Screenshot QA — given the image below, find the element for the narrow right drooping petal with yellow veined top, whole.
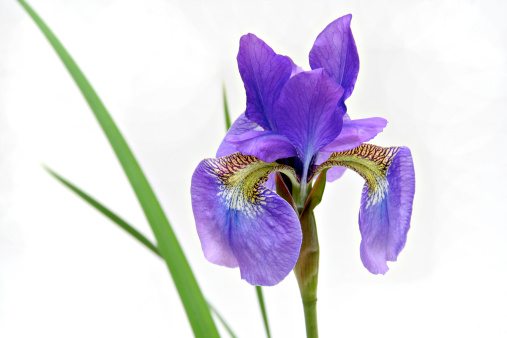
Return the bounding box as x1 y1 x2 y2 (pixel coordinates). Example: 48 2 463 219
316 144 415 274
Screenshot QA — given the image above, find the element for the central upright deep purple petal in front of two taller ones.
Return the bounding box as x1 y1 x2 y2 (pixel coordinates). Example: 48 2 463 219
274 69 343 163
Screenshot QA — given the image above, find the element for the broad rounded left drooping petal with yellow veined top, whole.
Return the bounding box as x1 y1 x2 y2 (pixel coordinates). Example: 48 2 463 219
191 153 302 285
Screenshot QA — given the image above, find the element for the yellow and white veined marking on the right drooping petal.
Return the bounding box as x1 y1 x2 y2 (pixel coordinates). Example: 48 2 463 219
312 143 400 208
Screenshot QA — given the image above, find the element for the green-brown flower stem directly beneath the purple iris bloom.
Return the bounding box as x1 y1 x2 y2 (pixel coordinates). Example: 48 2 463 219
294 210 319 338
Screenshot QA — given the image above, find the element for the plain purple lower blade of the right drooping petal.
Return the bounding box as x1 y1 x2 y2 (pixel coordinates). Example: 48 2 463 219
359 147 415 274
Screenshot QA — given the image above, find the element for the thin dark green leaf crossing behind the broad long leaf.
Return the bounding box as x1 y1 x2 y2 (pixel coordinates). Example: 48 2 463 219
42 165 236 338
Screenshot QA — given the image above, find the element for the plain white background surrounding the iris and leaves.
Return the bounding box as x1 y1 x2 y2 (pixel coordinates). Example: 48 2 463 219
0 0 507 338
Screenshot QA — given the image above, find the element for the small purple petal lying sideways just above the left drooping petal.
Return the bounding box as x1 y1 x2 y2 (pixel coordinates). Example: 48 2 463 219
226 130 297 163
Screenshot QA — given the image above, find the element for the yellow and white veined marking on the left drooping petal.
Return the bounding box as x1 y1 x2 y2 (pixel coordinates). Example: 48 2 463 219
202 153 295 216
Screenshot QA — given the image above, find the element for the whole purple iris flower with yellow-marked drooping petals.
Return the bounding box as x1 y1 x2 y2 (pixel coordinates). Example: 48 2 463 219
191 14 415 285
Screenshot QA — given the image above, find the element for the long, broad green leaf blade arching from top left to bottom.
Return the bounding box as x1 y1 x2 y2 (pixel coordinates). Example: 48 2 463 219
18 0 219 338
